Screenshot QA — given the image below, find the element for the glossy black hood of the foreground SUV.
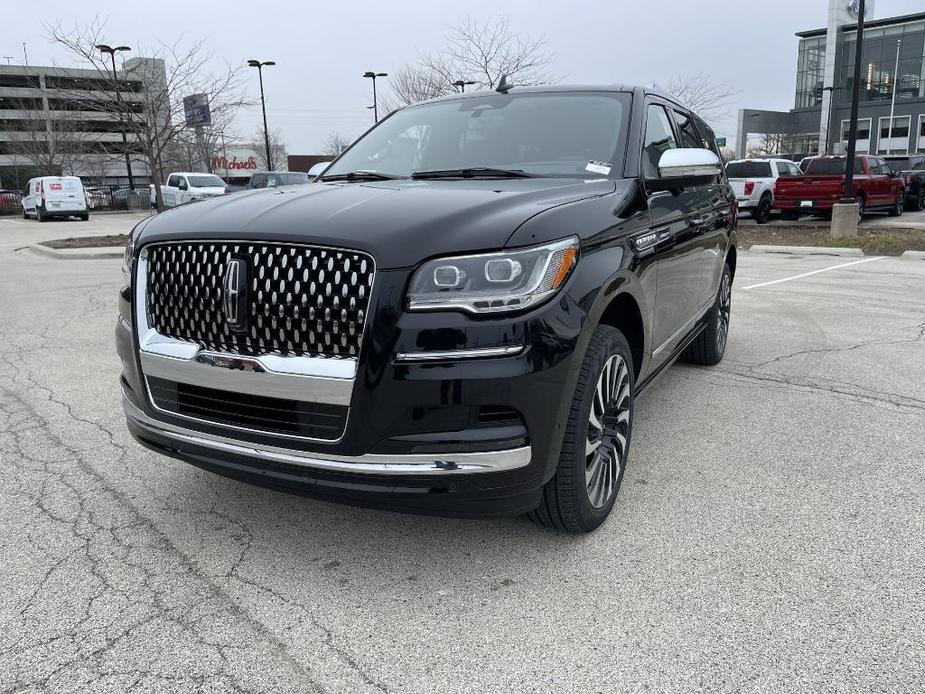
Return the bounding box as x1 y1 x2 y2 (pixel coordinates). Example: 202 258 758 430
139 178 616 269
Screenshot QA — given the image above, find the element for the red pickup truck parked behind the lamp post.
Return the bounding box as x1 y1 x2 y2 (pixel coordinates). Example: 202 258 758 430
774 154 906 219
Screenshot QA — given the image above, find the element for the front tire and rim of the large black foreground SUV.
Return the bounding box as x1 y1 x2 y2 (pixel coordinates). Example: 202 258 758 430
527 325 636 533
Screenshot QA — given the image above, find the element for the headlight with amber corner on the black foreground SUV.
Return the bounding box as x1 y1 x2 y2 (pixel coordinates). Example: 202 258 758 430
408 237 578 313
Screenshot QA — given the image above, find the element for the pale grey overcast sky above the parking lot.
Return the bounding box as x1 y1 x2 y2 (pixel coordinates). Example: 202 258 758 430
0 0 925 154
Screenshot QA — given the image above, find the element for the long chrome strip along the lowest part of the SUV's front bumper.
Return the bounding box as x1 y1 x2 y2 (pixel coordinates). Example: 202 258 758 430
122 392 532 475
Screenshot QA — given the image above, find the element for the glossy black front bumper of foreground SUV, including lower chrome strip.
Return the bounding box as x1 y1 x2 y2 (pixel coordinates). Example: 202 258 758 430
116 258 586 516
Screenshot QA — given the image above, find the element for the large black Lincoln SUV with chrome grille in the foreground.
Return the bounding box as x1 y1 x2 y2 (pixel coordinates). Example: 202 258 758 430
116 86 737 532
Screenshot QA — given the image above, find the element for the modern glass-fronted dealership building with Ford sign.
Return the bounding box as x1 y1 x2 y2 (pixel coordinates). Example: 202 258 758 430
737 13 925 156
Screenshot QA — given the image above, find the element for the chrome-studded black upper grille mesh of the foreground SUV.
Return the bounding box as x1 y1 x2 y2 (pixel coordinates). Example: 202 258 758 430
146 242 375 357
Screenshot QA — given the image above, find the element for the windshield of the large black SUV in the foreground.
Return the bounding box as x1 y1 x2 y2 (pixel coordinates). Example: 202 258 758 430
324 92 629 178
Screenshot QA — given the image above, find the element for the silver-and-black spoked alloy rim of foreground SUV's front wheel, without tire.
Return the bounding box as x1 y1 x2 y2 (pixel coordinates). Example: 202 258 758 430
585 354 632 508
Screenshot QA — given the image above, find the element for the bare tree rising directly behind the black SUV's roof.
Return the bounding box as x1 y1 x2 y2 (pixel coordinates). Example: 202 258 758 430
382 17 556 111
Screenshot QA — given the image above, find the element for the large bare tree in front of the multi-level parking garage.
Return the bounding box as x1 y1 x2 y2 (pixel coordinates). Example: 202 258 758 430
45 18 248 209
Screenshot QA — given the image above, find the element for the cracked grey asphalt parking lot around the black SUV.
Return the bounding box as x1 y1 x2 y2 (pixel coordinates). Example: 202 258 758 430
0 215 925 693
